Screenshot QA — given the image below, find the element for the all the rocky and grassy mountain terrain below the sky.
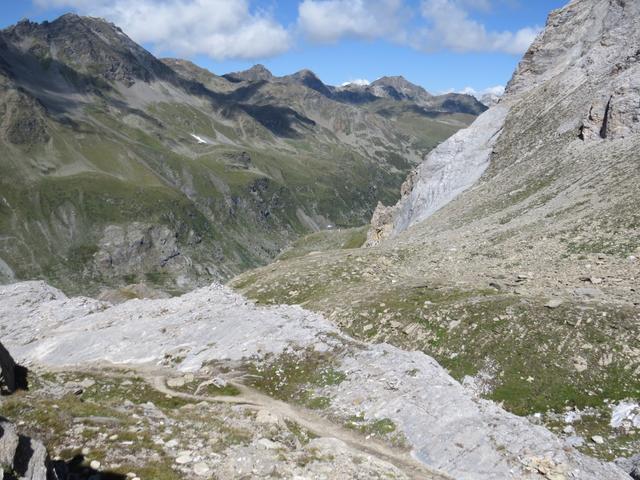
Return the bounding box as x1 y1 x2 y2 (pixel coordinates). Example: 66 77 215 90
0 0 640 480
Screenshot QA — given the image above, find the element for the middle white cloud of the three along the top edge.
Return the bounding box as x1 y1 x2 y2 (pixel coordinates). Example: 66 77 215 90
298 0 405 43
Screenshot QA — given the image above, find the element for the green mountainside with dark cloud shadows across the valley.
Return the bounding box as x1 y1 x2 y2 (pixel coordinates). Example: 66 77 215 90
0 15 474 293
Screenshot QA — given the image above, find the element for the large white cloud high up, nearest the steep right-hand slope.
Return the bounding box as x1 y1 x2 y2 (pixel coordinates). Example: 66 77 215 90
413 0 540 54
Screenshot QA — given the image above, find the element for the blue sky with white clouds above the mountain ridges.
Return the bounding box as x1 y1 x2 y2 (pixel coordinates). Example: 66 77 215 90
0 0 567 92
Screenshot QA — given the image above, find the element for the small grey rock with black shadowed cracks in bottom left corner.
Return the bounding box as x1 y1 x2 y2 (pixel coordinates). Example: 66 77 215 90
0 421 48 480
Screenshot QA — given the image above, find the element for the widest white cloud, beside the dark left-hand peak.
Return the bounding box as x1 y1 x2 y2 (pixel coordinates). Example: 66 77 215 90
35 0 292 60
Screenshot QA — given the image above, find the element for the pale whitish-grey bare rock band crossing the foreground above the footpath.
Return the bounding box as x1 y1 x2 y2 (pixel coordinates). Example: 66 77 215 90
0 282 628 480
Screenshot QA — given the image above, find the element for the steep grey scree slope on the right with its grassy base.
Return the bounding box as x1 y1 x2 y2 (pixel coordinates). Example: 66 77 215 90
231 0 640 458
